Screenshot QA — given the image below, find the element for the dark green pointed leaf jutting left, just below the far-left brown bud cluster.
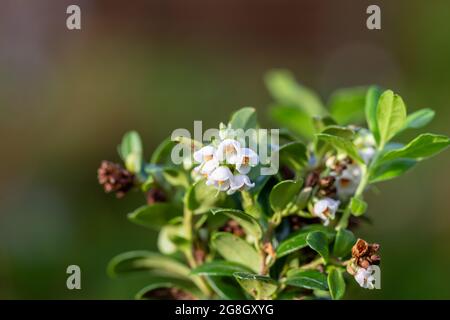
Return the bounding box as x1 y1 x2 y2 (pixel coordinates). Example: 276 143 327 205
128 202 183 230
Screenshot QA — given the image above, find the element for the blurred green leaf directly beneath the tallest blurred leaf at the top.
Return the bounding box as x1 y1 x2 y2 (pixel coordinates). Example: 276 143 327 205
269 105 315 139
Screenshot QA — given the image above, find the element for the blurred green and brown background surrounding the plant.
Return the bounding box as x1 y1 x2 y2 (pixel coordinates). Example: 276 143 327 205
0 0 450 299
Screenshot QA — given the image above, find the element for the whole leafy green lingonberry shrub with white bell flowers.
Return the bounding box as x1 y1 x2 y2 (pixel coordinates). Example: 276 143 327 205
98 71 449 299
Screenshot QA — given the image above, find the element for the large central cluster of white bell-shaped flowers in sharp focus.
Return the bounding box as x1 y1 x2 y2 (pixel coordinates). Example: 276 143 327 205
194 126 259 194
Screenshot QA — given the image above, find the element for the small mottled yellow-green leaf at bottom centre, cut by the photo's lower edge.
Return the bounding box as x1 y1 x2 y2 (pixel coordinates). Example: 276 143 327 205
234 272 278 299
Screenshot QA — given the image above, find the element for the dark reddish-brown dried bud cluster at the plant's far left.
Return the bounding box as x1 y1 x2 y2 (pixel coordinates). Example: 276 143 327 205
97 160 135 198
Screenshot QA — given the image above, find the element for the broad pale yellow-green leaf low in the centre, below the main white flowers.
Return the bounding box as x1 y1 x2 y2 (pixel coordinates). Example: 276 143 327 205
211 232 261 272
